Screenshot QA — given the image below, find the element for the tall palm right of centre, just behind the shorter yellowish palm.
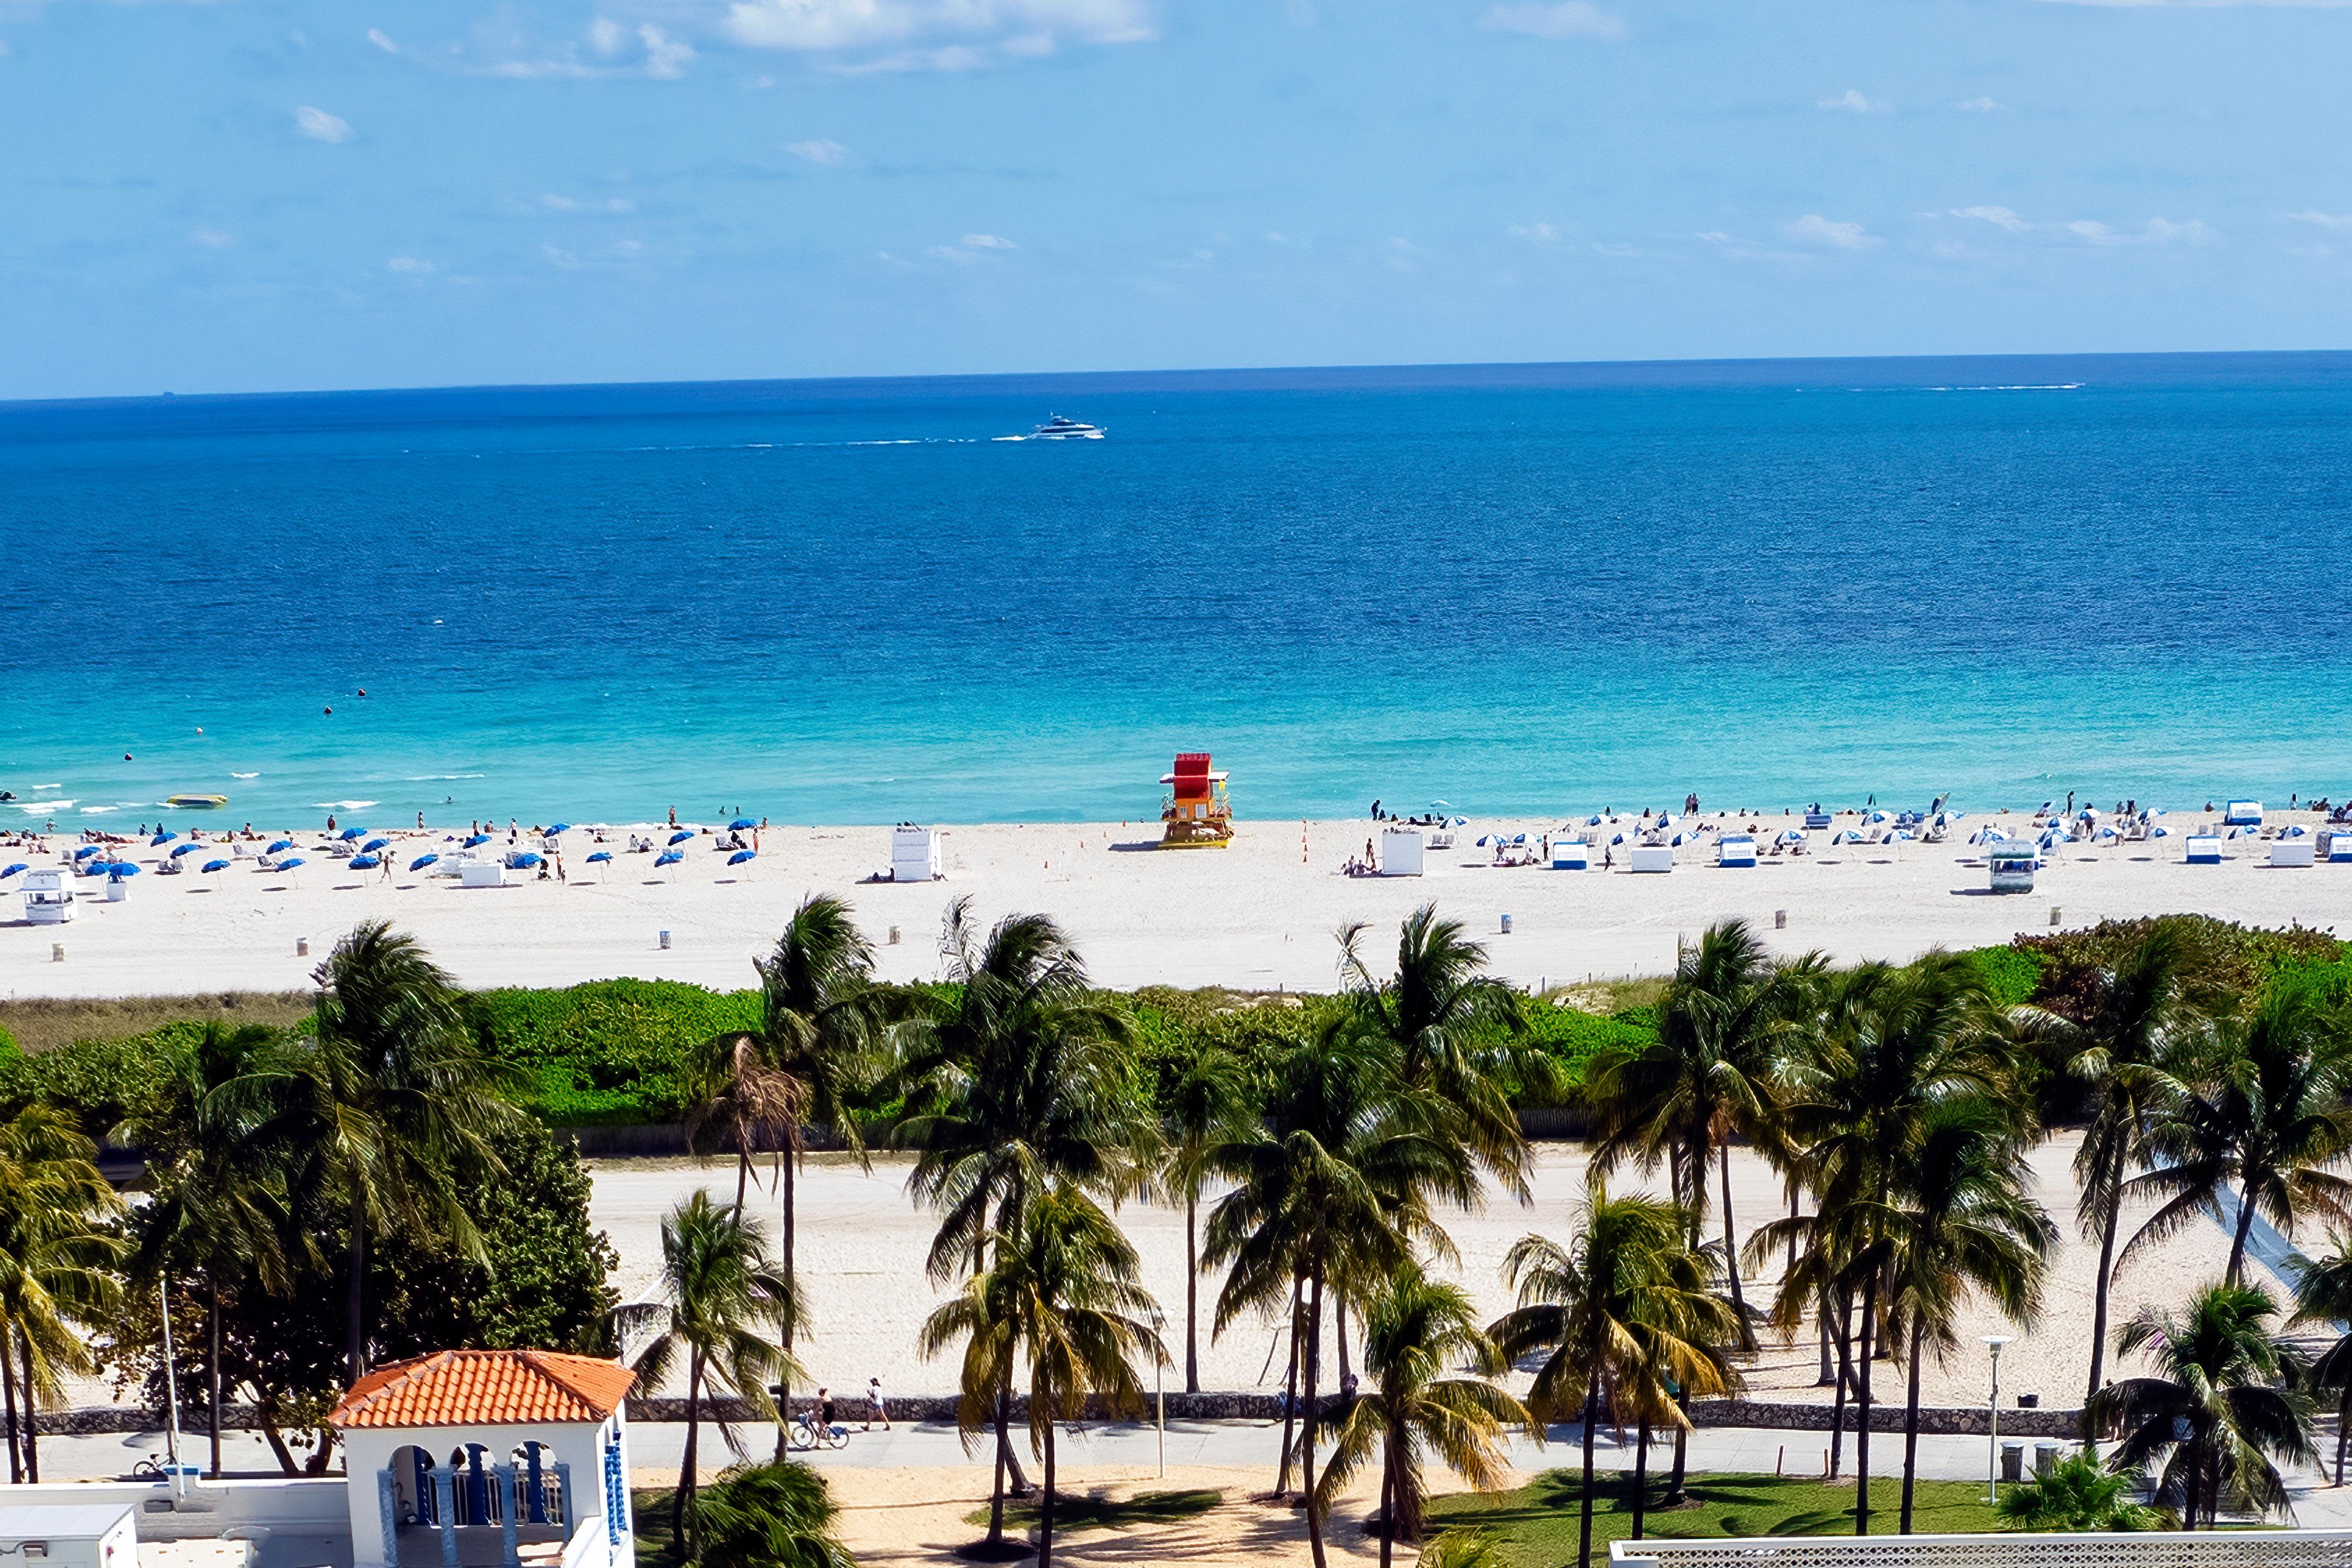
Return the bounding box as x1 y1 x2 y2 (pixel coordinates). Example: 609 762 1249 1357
1590 919 1820 1350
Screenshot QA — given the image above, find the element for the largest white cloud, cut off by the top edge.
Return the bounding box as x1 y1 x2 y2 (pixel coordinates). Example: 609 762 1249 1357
727 0 1157 71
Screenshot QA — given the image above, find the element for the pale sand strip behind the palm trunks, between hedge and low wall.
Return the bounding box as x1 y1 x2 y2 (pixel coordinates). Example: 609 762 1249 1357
591 1133 2277 1408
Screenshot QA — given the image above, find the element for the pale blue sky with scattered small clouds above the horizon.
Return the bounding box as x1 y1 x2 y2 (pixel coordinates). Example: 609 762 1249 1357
0 0 2352 397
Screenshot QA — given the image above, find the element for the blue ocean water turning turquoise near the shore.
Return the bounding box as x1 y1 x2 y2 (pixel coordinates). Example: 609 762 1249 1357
0 355 2352 827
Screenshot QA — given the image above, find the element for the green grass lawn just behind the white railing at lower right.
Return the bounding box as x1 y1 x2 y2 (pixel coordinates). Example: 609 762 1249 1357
1430 1469 1999 1568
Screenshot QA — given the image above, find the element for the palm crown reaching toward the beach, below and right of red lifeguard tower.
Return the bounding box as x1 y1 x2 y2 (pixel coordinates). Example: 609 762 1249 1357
1339 903 1560 1201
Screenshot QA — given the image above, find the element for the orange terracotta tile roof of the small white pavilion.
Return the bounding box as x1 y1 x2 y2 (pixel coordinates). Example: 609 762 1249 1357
327 1350 638 1427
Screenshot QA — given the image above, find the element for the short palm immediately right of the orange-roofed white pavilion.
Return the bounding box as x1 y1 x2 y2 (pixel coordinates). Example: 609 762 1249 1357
612 1187 800 1552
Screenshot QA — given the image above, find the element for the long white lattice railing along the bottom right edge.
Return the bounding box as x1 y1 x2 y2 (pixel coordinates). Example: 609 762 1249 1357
1609 1530 2352 1568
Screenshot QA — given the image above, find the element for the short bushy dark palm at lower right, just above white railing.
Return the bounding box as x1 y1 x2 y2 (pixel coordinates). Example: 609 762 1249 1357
2091 1284 2317 1530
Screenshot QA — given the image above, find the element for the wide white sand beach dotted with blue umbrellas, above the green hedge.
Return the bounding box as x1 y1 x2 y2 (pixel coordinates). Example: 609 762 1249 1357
0 813 2352 997
